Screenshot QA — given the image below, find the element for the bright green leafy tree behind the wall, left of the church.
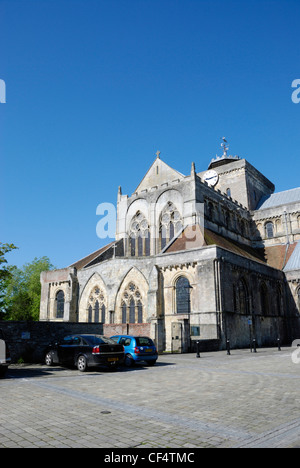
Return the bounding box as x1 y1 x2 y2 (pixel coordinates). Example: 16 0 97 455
4 257 54 321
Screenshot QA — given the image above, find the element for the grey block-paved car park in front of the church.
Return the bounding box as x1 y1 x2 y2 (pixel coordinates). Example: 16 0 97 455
0 348 300 448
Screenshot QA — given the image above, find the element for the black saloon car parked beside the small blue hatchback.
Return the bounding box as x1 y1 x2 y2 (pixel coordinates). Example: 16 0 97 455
45 335 125 372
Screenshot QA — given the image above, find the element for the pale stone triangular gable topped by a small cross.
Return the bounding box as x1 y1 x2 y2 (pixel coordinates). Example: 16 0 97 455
135 157 184 192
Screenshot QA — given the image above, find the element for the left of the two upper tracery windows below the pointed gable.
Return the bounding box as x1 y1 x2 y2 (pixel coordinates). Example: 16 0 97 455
129 211 150 257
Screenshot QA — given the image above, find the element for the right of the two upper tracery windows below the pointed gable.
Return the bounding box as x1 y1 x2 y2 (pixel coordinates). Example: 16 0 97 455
159 202 183 250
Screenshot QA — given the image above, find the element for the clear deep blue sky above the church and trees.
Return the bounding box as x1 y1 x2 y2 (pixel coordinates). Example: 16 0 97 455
0 0 300 268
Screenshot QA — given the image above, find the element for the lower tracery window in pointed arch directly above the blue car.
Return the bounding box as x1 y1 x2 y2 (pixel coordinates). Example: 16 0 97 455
121 282 143 323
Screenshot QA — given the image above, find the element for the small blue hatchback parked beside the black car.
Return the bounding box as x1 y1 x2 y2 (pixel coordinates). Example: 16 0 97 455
111 335 158 367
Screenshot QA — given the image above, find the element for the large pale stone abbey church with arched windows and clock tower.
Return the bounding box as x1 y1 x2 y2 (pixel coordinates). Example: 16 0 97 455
40 143 300 352
